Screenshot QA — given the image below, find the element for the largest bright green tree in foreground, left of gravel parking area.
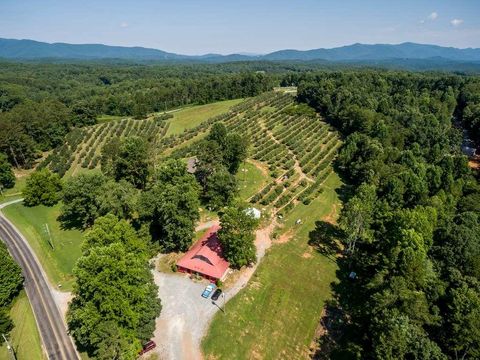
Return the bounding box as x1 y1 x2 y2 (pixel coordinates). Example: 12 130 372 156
67 243 161 359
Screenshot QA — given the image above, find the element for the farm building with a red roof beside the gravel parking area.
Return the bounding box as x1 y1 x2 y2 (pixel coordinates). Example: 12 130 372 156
177 225 229 281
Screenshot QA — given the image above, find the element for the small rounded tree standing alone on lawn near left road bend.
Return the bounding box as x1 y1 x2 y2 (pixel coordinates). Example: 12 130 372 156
23 169 62 206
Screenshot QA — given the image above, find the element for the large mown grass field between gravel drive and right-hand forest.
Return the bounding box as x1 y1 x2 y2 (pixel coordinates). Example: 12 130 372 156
202 174 340 359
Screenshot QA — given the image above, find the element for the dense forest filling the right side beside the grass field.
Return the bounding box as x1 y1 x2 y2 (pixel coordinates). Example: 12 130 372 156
289 71 480 359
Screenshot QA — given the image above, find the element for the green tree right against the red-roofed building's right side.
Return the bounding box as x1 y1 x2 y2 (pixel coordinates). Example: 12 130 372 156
218 206 258 269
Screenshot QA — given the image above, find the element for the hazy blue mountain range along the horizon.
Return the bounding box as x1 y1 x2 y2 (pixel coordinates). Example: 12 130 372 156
0 38 480 63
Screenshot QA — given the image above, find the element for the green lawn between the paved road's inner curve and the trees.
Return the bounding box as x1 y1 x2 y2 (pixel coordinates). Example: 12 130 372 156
3 204 82 291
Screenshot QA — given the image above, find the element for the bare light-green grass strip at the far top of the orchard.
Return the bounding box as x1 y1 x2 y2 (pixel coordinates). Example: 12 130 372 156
167 99 243 135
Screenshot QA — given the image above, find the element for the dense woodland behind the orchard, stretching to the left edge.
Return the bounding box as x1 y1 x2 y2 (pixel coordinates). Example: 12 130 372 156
0 63 275 172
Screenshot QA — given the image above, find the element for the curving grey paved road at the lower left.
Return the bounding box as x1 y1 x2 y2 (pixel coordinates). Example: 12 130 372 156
0 204 79 360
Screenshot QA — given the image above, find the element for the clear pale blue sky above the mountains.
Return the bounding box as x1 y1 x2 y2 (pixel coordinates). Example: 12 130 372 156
0 0 480 54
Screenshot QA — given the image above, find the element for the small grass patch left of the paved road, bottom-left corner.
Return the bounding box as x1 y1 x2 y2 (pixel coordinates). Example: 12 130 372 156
0 291 45 360
